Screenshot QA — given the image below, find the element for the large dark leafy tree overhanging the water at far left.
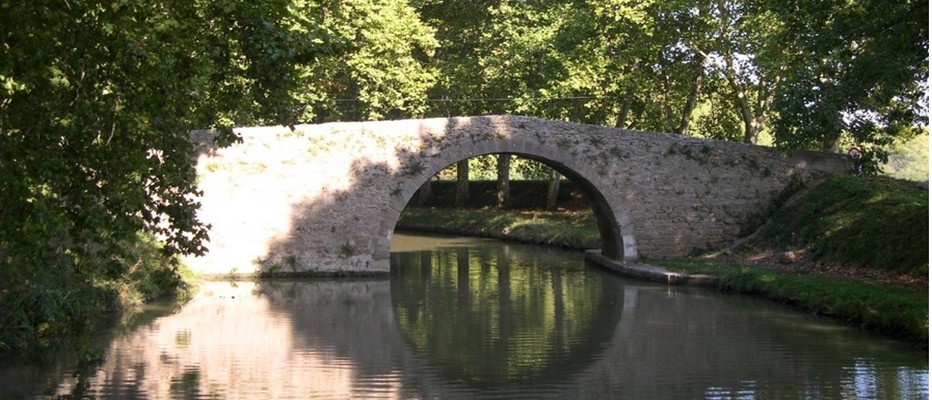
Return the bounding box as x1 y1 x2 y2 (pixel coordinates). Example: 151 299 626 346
0 0 327 348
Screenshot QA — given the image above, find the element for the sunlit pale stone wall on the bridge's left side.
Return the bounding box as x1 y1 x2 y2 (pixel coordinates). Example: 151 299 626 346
188 120 460 274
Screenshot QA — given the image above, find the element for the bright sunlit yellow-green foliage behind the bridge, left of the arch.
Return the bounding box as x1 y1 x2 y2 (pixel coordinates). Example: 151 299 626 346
295 0 438 122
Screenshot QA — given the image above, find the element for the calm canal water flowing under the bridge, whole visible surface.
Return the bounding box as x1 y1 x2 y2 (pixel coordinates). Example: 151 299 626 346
0 234 929 399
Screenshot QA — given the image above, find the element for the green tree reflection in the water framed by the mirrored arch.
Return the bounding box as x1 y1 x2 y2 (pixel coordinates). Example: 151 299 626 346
391 239 622 385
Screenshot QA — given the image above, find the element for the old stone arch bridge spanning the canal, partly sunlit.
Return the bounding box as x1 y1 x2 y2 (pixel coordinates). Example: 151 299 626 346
186 116 846 275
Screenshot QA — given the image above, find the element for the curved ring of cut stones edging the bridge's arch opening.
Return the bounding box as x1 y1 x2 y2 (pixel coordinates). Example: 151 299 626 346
375 139 638 260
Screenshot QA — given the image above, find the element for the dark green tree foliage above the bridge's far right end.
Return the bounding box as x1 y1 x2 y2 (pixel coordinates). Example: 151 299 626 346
768 0 929 168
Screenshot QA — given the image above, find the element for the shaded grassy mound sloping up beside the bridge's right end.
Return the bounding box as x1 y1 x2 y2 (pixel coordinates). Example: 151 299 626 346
748 176 929 277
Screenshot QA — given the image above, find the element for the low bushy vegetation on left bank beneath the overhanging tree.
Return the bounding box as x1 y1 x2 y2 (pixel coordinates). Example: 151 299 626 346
0 234 196 359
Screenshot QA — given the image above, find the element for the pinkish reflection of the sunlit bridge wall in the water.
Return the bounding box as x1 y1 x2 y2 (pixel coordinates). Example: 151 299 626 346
92 282 396 398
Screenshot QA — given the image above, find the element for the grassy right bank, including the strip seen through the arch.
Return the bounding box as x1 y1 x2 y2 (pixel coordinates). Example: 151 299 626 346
397 177 929 349
